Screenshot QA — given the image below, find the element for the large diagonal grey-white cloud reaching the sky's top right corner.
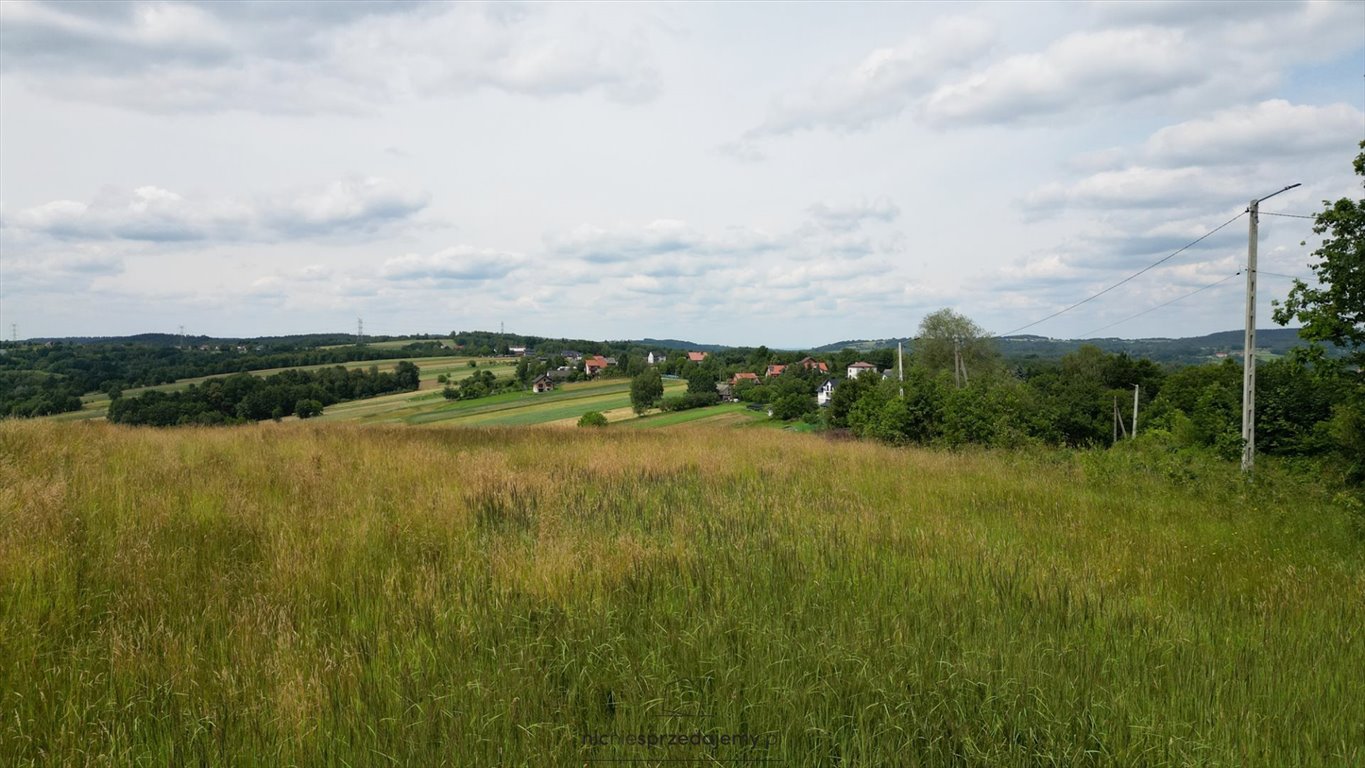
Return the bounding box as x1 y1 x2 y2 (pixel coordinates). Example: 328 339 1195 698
742 3 1362 141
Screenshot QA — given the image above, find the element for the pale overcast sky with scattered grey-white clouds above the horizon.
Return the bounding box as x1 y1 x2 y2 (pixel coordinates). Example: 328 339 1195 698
0 0 1365 348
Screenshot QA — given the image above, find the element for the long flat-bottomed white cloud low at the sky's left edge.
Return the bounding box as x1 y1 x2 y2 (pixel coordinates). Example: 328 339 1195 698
4 177 429 243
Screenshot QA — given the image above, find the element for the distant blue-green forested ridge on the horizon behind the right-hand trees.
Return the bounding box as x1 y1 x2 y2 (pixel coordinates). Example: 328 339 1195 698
814 327 1332 363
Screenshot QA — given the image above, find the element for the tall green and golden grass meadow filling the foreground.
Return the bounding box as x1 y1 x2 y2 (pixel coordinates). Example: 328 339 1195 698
0 422 1365 767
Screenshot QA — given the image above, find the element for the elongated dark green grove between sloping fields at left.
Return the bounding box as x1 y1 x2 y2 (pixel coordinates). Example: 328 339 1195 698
109 360 420 427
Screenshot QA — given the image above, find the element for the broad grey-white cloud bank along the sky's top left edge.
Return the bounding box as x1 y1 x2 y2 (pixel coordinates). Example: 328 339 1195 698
0 0 659 113
